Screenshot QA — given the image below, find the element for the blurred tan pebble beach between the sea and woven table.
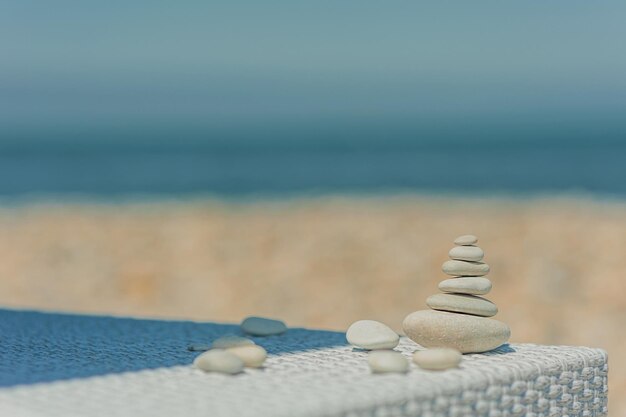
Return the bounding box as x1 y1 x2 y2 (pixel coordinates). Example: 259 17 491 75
0 195 626 416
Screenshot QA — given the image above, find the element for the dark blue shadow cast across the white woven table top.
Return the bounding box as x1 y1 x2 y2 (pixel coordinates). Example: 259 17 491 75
0 309 347 387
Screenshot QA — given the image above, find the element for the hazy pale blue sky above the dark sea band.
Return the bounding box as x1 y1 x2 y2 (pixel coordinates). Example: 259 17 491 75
0 0 626 140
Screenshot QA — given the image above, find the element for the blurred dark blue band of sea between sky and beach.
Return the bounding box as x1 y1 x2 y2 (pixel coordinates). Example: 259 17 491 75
0 138 626 198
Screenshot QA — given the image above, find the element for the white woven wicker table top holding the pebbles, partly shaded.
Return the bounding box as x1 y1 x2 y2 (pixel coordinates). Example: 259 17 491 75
0 310 608 417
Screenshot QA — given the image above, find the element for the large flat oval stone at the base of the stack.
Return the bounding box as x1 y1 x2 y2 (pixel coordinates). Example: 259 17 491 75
402 310 511 353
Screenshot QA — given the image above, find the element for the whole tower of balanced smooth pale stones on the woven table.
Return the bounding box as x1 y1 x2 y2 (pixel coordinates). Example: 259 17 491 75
403 235 511 353
